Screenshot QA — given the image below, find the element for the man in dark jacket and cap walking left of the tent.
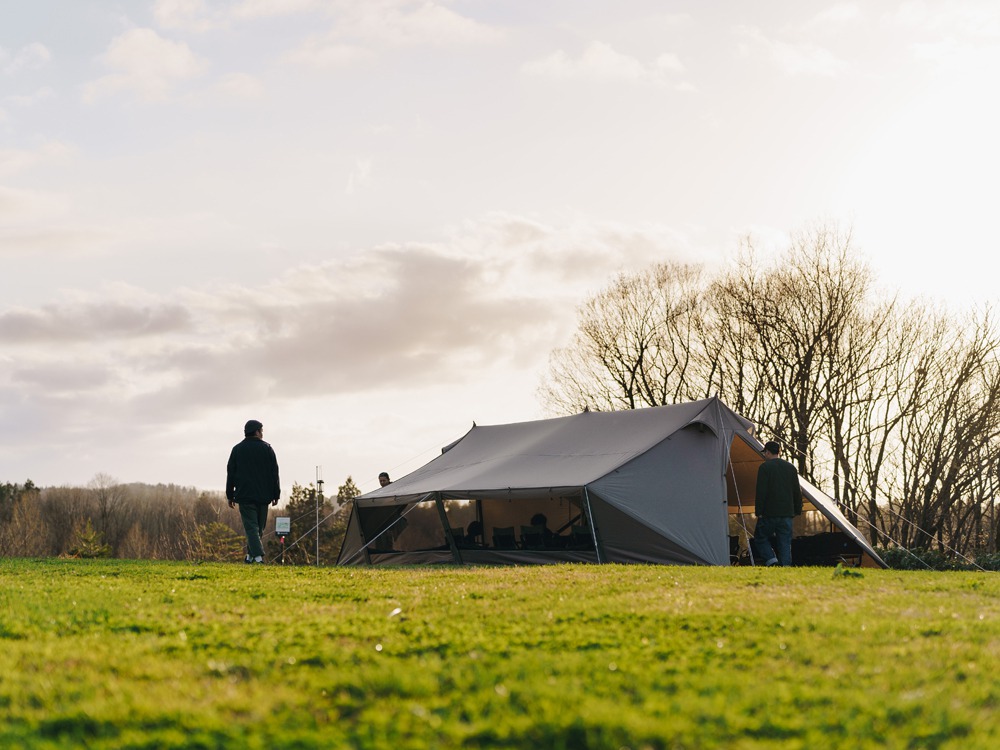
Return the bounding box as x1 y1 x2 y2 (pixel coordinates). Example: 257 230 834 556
226 419 281 563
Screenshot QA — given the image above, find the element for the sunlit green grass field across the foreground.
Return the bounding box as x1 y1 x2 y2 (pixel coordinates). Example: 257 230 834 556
0 560 1000 750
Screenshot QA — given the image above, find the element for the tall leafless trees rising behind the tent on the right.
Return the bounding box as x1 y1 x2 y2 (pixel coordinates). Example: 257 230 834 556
540 227 1000 555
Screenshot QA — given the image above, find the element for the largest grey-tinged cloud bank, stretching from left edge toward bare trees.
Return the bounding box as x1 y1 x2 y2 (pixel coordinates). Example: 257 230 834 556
0 214 696 434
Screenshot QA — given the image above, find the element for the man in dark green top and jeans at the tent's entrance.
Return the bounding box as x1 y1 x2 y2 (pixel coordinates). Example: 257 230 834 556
752 440 802 566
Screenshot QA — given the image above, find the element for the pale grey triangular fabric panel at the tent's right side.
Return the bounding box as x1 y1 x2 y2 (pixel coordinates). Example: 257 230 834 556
589 426 729 565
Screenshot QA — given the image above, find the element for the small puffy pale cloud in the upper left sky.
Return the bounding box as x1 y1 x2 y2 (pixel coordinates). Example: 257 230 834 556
83 29 208 103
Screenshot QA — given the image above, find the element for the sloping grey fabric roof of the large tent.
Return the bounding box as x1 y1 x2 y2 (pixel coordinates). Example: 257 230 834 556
358 398 751 504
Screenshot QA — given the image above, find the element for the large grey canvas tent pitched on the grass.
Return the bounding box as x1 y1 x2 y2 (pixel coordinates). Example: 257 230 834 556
338 398 885 567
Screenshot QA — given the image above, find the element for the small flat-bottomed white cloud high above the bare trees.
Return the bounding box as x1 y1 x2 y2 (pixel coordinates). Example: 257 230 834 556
521 41 692 89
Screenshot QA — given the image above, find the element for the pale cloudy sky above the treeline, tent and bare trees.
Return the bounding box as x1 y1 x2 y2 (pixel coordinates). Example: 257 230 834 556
0 0 1000 496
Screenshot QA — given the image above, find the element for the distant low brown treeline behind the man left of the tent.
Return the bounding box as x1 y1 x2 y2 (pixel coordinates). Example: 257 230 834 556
0 474 359 564
